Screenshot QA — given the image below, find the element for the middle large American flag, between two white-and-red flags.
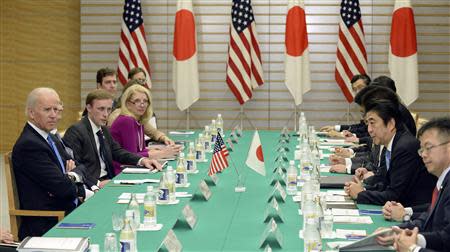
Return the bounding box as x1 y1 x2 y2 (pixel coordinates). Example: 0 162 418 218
227 0 264 105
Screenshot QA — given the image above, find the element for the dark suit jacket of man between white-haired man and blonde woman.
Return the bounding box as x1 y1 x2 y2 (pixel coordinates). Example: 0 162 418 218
63 116 141 184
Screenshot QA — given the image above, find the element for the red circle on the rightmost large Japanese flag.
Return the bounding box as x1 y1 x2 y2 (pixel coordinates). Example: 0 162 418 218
391 7 417 57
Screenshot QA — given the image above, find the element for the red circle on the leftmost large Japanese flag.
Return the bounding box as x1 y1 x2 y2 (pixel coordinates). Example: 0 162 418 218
173 9 197 60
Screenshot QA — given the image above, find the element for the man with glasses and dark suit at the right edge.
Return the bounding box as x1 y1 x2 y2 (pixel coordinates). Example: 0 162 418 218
378 117 450 251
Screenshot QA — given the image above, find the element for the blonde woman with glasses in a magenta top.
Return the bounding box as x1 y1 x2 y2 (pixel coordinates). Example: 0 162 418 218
110 85 179 174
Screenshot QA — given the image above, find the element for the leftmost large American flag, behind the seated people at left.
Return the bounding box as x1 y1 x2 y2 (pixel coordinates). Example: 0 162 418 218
117 0 151 87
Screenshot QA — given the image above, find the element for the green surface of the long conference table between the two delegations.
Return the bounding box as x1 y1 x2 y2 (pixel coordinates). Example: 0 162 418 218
45 131 395 251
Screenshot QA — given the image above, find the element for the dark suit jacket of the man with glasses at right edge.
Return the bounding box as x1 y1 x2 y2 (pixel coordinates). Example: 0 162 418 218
400 173 450 251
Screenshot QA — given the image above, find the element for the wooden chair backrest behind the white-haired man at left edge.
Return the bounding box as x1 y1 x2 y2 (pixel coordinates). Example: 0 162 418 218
4 152 20 238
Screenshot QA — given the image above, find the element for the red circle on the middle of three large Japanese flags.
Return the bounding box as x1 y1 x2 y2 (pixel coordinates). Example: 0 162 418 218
284 6 308 57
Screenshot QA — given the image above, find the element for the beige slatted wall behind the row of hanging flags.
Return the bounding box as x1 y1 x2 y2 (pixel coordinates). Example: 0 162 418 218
81 0 450 132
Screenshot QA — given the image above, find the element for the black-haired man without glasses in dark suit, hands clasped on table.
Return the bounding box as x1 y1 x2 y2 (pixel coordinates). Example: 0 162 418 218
344 99 436 206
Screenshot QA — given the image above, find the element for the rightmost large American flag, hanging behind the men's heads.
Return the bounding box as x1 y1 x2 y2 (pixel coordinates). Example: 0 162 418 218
334 0 367 103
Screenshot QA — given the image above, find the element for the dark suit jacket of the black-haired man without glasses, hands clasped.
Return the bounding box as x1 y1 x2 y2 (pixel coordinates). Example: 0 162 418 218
356 130 436 206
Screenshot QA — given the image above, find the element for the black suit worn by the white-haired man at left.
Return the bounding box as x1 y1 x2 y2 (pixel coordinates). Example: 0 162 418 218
12 123 85 239
